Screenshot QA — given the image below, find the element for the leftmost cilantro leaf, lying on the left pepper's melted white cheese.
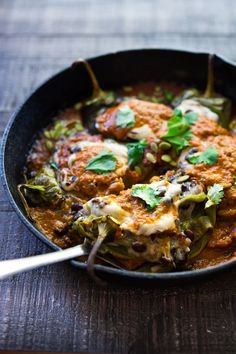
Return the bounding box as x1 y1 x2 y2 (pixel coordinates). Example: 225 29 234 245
85 150 116 174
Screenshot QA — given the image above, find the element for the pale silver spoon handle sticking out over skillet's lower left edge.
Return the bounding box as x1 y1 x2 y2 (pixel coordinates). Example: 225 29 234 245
0 245 85 280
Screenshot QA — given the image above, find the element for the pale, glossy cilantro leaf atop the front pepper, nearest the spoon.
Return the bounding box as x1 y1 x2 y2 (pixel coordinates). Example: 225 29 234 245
131 184 163 209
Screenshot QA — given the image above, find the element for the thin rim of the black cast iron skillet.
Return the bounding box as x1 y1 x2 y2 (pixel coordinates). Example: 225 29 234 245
0 48 236 283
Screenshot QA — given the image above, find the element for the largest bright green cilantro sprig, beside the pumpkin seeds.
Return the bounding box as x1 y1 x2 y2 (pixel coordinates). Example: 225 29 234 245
161 109 198 152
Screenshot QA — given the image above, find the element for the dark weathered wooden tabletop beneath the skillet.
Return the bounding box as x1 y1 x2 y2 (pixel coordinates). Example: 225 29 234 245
0 0 236 354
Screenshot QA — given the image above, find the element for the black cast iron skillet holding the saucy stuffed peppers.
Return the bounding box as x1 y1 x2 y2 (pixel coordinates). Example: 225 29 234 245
1 49 236 284
